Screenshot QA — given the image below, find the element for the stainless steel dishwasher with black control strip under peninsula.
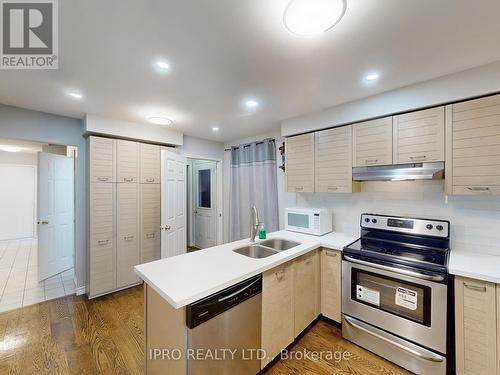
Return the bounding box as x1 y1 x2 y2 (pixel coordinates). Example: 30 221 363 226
186 275 262 375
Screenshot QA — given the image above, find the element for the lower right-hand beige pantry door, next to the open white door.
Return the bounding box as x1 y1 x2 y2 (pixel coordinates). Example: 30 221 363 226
140 184 161 263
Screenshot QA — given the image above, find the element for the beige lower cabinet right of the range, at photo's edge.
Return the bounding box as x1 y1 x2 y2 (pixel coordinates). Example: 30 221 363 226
455 277 500 375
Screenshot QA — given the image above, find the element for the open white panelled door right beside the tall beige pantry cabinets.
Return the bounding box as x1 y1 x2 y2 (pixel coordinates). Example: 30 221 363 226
160 150 187 258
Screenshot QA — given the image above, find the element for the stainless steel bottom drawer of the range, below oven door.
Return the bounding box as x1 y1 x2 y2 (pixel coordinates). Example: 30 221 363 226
342 314 446 375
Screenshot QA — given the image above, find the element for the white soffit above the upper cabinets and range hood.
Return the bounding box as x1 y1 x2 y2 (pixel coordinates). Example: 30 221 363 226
281 61 500 136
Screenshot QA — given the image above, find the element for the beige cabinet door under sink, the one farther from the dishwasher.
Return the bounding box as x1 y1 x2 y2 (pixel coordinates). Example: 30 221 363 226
293 251 320 337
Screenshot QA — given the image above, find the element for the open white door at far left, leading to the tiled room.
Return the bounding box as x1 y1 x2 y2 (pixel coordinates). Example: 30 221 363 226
38 152 75 281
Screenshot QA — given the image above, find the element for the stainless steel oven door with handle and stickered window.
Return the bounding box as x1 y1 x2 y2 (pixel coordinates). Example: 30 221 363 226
342 260 447 354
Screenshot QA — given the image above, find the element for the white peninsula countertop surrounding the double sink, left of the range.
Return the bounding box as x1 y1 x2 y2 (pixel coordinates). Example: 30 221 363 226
134 231 357 309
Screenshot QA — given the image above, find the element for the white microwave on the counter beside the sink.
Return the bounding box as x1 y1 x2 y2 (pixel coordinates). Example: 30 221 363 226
285 207 333 236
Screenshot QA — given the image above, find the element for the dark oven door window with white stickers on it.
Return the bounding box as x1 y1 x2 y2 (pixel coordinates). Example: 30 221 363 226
351 268 431 327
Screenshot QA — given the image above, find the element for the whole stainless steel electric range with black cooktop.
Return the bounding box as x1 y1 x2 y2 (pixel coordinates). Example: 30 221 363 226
342 214 453 374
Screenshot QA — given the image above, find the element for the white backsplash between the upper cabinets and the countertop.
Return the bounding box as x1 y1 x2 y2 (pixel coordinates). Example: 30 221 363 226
297 180 500 255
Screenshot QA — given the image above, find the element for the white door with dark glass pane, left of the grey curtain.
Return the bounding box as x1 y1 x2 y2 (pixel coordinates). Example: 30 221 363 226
193 161 217 249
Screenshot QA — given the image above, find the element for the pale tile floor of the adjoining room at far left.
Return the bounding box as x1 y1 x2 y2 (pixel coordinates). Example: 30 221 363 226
0 239 76 312
